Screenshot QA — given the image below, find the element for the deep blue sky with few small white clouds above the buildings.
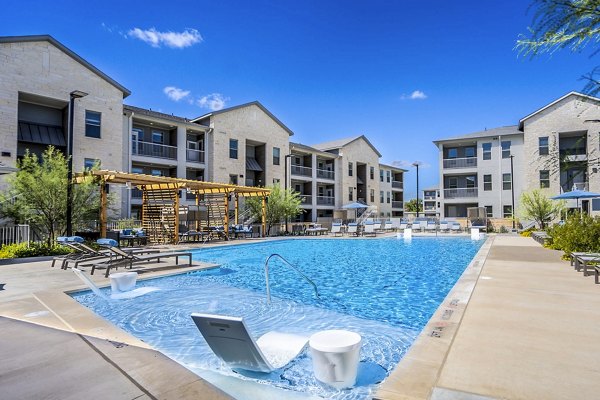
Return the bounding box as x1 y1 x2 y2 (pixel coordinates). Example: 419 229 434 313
0 0 595 199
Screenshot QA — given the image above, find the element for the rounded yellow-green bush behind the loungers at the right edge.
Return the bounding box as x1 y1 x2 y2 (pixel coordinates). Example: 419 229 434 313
548 214 600 254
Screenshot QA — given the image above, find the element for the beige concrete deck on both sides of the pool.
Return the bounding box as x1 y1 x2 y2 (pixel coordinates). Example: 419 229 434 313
0 235 600 400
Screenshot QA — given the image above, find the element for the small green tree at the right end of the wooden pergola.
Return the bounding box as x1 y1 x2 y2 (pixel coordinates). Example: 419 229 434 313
246 185 302 235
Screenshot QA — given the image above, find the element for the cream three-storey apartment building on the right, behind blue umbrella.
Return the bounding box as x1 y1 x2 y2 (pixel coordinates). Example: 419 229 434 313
434 92 600 218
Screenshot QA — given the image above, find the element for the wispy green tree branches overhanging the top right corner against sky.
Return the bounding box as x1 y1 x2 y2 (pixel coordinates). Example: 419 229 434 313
516 0 600 95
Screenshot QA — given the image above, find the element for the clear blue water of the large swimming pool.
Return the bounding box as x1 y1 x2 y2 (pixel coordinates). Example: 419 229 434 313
73 237 483 399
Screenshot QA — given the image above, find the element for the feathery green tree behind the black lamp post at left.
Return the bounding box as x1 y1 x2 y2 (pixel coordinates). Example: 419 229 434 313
0 146 100 244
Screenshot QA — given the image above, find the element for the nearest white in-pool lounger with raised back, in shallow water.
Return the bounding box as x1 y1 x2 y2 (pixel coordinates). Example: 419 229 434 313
192 313 308 373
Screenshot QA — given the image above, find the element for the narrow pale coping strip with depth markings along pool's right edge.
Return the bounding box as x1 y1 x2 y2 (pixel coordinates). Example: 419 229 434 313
373 235 495 400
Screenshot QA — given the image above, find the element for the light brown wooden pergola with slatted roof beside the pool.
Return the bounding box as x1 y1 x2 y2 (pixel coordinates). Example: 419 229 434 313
74 170 270 243
